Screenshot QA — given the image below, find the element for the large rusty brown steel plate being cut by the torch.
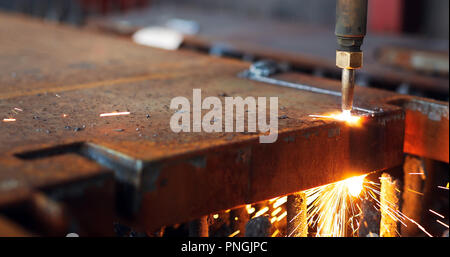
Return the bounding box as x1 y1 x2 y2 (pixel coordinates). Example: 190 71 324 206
0 14 414 231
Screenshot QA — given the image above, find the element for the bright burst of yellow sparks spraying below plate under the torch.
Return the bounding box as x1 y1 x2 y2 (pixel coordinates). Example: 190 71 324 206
304 176 432 237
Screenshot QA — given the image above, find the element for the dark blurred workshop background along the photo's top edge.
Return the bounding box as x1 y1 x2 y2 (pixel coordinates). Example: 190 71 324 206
0 0 449 39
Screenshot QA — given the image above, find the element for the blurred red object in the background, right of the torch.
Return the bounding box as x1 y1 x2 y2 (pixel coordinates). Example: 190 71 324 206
368 0 405 33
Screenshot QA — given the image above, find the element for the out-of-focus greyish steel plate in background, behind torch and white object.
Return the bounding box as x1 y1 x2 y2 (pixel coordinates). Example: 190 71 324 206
89 5 449 95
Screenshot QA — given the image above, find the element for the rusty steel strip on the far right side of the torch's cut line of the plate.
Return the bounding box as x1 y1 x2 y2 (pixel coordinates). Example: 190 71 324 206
276 73 449 163
